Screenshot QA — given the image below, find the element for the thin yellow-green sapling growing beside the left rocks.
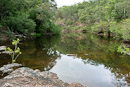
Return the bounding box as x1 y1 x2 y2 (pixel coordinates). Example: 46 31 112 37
5 38 22 63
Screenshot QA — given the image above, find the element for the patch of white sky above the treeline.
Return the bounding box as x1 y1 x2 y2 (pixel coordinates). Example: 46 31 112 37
55 0 86 7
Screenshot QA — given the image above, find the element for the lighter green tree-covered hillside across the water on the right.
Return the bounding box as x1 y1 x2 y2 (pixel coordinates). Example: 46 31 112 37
57 0 130 40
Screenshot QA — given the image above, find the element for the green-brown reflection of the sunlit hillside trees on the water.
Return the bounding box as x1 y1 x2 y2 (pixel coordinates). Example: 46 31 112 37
57 34 130 86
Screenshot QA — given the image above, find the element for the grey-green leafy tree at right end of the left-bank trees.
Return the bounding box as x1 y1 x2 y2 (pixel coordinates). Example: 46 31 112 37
29 6 61 35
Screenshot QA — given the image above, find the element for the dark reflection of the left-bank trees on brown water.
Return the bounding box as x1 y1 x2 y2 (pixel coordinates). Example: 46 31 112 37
18 36 60 71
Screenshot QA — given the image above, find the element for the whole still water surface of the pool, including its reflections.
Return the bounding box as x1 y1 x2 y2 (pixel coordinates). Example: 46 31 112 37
0 34 130 87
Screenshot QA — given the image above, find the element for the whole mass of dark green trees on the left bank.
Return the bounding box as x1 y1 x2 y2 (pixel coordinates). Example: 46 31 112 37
0 0 60 39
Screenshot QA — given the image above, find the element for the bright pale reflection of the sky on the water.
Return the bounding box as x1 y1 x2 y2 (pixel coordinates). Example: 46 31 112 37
50 55 125 87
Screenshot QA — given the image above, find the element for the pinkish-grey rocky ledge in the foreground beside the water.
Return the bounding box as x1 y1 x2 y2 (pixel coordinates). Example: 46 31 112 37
0 67 86 87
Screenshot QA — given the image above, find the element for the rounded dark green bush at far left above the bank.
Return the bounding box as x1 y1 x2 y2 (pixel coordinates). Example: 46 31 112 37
2 13 36 35
